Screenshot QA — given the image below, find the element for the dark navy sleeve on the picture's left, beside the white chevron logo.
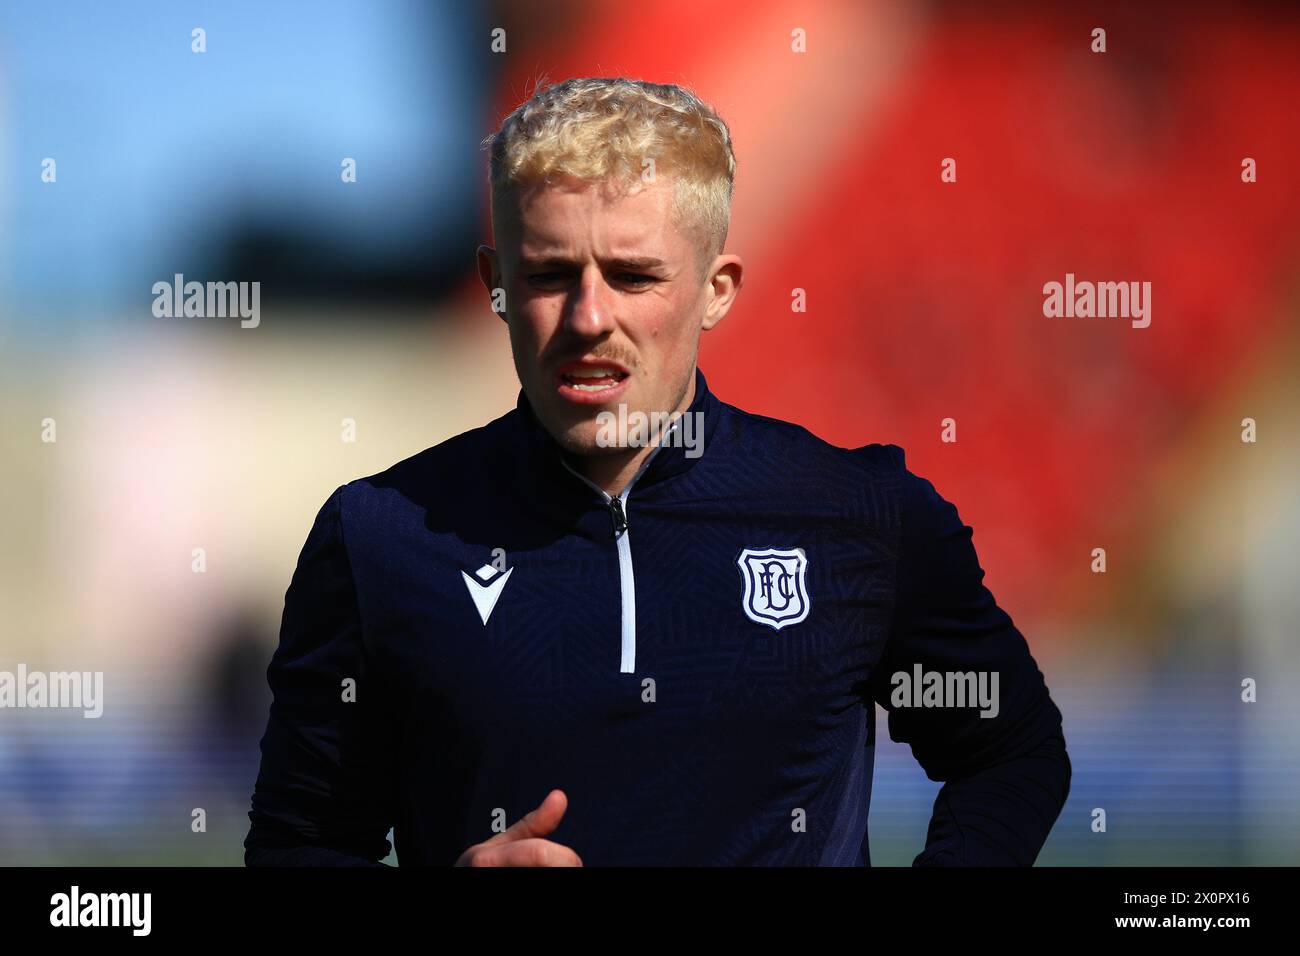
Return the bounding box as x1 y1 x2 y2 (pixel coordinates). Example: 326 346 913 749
244 488 394 866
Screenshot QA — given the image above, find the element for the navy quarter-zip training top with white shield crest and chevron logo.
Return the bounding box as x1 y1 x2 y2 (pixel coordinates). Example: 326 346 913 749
244 369 1071 866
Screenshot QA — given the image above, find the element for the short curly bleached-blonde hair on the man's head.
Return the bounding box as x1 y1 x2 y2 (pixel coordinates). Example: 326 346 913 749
482 77 736 273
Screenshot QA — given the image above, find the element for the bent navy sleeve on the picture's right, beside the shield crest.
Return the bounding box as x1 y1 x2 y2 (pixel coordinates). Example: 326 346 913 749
872 445 1071 866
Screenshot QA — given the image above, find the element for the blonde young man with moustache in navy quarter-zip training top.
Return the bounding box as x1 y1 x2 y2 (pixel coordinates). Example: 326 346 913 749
244 78 1070 866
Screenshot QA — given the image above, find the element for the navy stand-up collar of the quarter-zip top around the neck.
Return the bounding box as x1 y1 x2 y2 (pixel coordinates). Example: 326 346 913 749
515 367 722 497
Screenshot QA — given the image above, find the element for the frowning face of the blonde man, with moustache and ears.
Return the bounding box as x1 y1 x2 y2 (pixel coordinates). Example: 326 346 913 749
478 176 738 455
